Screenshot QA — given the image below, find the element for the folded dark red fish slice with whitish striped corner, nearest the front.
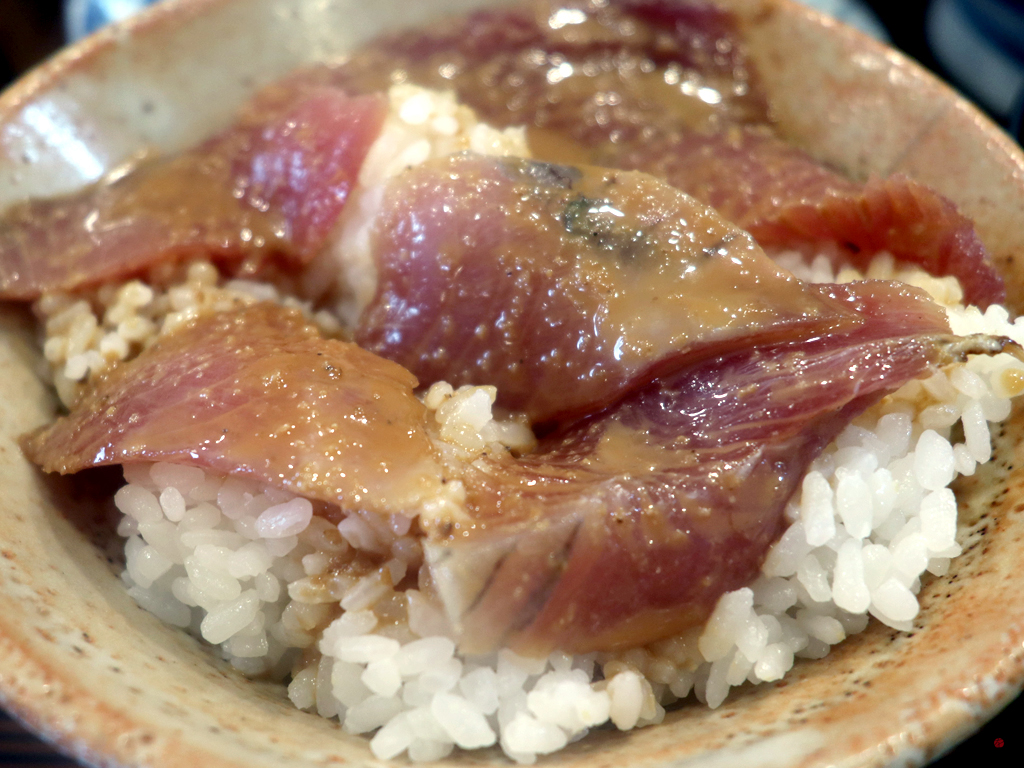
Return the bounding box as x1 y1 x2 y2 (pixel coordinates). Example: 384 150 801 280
425 335 1002 655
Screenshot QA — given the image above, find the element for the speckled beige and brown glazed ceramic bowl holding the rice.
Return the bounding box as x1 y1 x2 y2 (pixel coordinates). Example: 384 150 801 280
0 0 1024 768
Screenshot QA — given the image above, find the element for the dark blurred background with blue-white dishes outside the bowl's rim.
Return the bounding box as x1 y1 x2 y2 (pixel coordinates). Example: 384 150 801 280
0 0 1024 768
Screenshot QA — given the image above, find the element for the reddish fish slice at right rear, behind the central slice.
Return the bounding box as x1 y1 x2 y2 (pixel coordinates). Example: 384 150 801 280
606 129 1006 307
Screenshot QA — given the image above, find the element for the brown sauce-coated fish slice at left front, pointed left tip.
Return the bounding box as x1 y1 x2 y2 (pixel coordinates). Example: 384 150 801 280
23 304 443 513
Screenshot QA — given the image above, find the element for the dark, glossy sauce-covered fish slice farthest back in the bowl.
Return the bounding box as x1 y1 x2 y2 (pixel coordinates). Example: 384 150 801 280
327 0 768 147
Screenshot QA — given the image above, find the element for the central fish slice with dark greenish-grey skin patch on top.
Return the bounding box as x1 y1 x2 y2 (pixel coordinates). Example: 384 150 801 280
355 154 945 425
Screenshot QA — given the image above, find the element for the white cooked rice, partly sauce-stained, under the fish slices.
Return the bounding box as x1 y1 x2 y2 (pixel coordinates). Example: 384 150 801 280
25 85 1024 764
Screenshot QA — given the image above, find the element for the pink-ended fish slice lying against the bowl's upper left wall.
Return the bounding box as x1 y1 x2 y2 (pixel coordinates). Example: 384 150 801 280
0 82 386 299
